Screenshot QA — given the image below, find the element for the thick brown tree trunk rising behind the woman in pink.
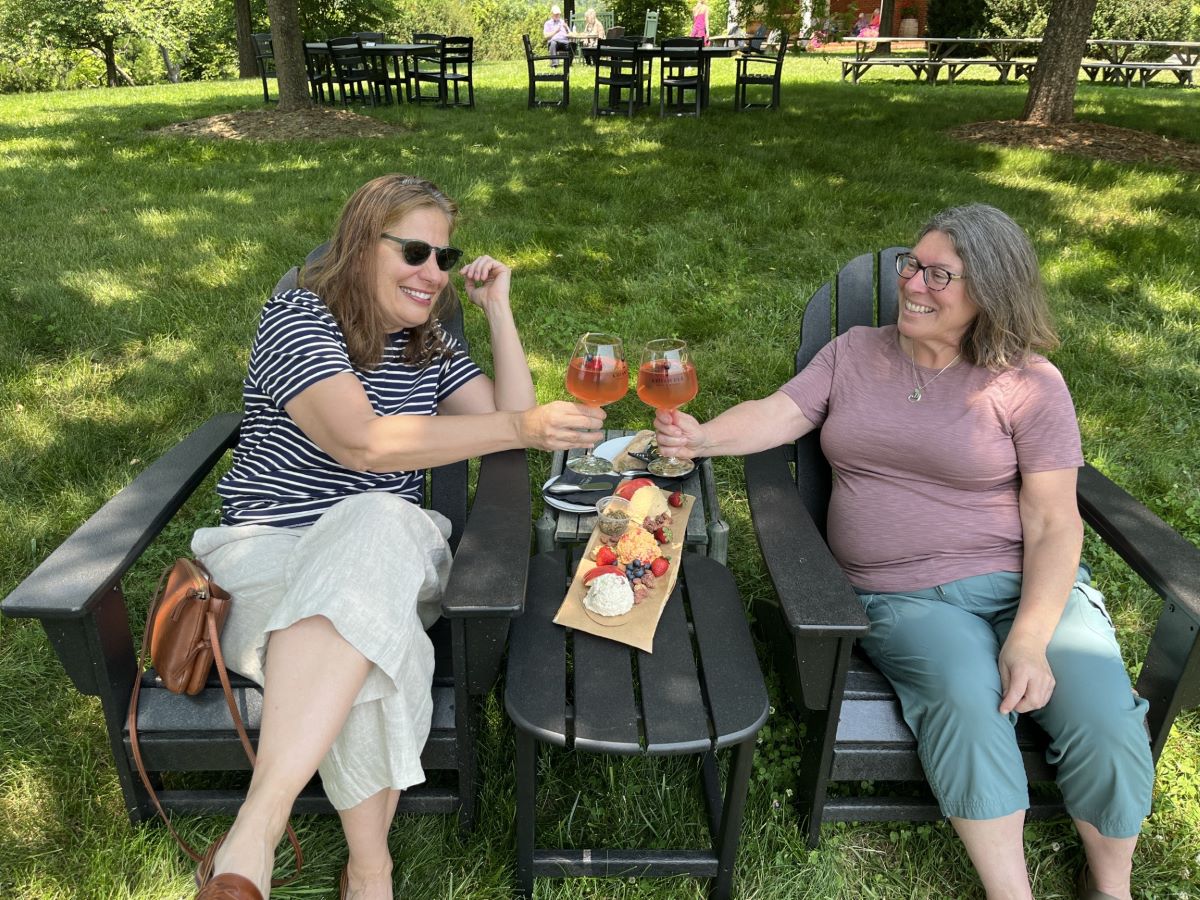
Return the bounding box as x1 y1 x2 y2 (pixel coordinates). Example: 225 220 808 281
1021 0 1096 125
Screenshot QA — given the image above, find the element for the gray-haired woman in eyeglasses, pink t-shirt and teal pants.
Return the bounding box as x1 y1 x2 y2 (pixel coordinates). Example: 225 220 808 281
655 205 1153 900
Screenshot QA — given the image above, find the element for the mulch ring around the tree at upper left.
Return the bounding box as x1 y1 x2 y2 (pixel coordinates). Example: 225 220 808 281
156 107 407 140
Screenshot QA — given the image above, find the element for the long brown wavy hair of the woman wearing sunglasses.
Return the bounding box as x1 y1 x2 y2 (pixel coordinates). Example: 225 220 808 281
300 175 458 370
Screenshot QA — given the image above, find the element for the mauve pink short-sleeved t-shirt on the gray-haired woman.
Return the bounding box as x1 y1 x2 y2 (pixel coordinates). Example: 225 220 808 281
780 325 1084 593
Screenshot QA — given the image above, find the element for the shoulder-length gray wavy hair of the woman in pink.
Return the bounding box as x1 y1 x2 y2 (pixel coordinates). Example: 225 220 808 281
918 203 1058 372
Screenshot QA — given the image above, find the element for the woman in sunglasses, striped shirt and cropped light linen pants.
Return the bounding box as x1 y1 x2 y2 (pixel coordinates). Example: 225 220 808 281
192 175 604 900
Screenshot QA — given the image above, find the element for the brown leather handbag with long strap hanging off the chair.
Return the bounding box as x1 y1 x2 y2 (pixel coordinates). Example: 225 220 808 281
128 558 304 887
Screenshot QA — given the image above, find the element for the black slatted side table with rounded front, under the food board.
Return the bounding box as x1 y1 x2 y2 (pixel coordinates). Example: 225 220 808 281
504 551 769 899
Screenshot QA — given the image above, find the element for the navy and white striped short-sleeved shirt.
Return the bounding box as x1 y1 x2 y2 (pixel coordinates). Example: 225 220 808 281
217 289 481 528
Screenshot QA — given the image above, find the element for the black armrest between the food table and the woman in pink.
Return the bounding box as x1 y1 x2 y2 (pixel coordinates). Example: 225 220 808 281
743 448 869 637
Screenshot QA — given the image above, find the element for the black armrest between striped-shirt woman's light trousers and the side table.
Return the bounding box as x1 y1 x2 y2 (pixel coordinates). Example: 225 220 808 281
442 450 533 618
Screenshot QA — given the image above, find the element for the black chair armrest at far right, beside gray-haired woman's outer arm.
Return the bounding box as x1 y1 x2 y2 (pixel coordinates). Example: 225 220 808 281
1076 466 1200 625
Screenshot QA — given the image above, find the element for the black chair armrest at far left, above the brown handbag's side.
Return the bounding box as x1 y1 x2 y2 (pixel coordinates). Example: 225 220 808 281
0 413 241 619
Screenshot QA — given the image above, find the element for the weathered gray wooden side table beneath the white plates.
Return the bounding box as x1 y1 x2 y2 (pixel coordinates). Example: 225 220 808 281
534 428 730 565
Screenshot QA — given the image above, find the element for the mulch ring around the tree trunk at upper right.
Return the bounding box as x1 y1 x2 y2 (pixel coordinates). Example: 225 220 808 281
948 121 1200 172
